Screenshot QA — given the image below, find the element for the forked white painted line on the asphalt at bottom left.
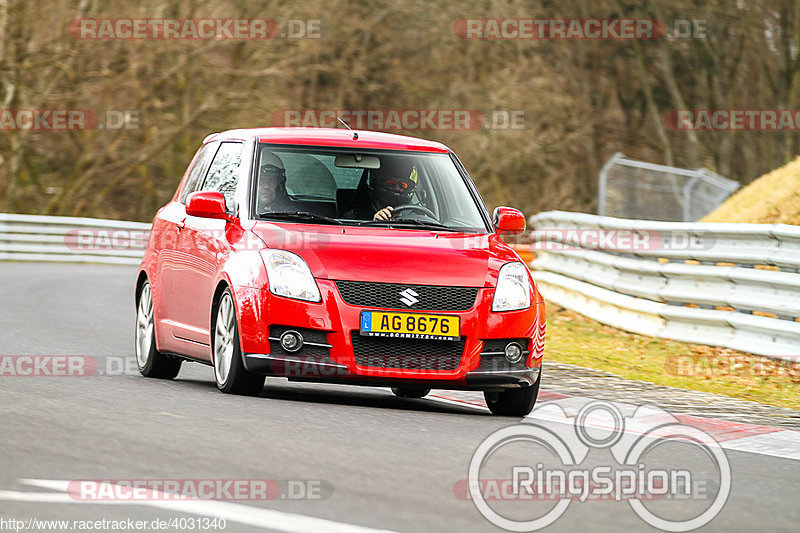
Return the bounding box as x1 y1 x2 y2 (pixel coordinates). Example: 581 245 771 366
8 479 395 533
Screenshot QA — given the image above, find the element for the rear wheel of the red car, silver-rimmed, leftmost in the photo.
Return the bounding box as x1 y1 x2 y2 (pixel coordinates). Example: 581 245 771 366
135 281 181 379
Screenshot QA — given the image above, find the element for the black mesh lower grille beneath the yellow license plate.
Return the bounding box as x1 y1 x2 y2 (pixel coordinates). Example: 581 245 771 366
350 331 464 370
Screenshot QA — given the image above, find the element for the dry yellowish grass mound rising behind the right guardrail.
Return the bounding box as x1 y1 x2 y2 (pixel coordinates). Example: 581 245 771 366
701 153 800 224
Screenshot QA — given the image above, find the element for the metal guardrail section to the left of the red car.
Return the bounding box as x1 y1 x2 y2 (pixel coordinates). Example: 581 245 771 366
0 213 150 265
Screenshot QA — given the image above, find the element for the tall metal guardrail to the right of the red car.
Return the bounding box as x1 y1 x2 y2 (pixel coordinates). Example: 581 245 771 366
530 211 800 358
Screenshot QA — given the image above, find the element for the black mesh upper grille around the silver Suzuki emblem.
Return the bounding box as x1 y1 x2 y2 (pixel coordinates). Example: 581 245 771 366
336 281 478 311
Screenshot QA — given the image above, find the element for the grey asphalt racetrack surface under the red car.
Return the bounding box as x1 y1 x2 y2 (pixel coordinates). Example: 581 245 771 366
0 263 800 532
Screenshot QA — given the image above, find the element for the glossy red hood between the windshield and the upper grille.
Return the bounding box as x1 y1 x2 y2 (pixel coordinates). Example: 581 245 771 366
251 222 519 287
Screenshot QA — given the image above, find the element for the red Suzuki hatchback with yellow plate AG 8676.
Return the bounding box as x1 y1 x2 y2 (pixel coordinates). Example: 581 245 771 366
136 128 545 416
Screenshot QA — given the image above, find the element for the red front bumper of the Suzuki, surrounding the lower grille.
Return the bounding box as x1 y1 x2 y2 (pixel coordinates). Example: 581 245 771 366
234 279 544 390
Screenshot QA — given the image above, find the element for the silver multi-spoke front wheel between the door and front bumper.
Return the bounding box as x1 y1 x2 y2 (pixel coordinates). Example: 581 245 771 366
211 288 265 396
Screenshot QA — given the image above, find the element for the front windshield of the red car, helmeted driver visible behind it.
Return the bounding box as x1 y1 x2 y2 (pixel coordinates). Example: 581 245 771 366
252 144 490 233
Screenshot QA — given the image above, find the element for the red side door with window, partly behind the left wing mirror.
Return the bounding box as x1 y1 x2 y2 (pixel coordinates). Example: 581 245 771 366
175 142 244 352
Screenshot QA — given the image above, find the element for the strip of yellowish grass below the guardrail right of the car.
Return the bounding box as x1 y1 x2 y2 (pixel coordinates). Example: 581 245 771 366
545 303 800 409
